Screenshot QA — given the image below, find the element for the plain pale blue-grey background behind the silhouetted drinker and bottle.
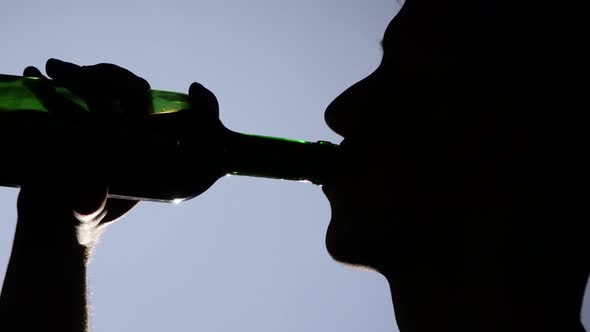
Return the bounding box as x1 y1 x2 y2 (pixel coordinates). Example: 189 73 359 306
0 0 590 332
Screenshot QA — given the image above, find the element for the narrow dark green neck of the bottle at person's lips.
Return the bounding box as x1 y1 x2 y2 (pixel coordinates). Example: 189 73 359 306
224 130 338 185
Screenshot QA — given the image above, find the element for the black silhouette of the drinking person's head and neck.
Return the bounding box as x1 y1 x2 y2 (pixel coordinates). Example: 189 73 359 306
324 0 590 331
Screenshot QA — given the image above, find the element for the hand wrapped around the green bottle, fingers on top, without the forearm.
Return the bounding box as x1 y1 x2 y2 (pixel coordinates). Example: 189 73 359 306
18 59 150 237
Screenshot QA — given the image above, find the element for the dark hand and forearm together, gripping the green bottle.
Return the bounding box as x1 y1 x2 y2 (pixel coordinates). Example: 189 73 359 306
0 60 162 331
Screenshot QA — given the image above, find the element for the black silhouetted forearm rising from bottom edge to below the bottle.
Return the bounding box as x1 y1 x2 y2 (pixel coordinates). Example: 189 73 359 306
0 188 92 332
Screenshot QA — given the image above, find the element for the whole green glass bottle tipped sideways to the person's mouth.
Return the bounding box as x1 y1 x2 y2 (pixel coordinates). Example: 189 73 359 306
0 75 338 202
